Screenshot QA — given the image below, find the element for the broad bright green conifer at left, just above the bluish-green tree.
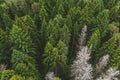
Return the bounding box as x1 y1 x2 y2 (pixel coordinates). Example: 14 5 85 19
10 25 33 55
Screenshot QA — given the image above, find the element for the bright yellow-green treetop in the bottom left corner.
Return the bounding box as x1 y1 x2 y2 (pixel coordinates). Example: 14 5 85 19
1 70 15 80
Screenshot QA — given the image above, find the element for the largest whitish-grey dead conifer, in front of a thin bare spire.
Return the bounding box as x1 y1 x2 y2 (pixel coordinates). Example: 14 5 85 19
71 47 93 80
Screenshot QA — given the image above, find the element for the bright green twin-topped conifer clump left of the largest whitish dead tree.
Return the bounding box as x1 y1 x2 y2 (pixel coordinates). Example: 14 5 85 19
43 40 68 69
